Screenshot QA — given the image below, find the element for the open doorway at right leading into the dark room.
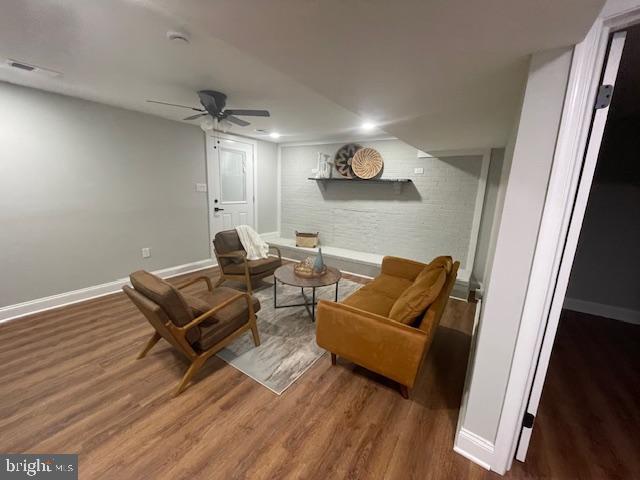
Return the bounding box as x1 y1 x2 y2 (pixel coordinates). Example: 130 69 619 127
516 25 640 478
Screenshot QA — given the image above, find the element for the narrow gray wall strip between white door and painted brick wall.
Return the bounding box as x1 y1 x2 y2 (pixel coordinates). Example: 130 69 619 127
256 140 278 233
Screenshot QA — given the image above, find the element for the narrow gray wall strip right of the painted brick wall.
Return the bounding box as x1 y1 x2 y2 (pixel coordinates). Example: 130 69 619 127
471 148 506 288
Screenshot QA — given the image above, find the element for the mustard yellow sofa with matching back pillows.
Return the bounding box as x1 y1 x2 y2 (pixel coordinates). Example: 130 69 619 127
316 257 460 398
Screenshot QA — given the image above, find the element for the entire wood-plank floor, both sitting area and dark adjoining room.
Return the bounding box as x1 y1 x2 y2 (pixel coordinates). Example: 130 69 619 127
0 270 640 480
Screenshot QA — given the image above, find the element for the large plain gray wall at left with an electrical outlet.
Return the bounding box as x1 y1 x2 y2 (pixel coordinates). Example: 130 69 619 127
0 83 209 306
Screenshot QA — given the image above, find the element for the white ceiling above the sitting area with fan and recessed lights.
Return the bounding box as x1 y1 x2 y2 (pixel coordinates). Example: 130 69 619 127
0 0 603 150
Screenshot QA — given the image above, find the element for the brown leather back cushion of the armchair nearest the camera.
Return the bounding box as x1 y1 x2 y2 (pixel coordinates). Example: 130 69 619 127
129 270 200 342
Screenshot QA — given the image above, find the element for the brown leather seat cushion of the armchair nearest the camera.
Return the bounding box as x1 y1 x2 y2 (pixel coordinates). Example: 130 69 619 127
193 287 260 351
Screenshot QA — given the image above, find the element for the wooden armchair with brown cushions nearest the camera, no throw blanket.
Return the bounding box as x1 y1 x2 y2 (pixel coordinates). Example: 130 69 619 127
123 270 260 396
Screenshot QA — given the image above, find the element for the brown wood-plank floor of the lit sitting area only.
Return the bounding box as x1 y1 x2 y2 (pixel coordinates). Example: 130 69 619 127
0 270 492 480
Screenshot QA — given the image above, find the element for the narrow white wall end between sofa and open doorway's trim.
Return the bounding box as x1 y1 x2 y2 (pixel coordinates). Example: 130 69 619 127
457 49 571 448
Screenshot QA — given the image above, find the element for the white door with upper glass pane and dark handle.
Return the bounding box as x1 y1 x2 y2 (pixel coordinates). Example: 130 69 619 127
207 133 255 245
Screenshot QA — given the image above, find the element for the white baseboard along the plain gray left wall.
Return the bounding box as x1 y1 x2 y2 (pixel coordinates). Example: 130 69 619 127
0 258 216 323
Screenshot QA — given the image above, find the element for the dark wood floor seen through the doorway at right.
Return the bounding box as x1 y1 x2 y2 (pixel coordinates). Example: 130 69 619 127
508 310 640 480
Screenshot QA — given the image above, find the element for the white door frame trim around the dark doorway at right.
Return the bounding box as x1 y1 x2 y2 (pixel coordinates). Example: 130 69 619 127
491 0 640 473
